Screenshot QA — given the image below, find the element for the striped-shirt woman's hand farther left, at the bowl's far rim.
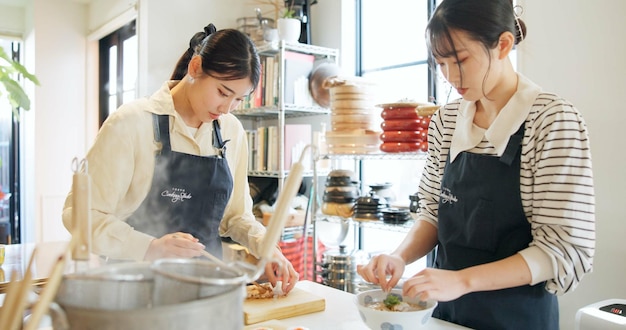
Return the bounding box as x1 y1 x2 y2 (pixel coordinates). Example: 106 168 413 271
357 254 405 292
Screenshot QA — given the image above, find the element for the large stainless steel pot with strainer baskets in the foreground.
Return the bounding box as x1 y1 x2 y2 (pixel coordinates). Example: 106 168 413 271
53 259 247 330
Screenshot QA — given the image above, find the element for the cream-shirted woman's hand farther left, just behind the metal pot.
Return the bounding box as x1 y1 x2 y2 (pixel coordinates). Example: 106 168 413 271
143 232 205 261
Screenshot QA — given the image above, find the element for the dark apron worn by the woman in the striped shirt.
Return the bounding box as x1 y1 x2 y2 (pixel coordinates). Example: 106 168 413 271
433 124 559 330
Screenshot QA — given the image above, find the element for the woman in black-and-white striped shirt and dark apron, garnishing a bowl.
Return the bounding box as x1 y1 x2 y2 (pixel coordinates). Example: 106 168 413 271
358 0 595 329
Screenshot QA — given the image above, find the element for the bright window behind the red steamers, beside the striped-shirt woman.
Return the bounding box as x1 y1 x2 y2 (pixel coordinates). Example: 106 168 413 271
348 0 436 207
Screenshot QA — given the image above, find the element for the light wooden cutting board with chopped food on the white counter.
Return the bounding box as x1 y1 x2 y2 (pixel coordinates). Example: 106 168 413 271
243 288 326 325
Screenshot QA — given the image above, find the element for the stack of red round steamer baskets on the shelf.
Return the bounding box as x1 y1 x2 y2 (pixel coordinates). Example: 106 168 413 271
378 102 439 153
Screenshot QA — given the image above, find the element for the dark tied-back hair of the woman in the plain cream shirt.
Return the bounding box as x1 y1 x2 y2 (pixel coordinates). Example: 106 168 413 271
170 24 261 88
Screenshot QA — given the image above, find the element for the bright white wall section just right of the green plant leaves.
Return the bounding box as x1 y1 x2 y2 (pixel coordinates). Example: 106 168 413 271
22 0 87 241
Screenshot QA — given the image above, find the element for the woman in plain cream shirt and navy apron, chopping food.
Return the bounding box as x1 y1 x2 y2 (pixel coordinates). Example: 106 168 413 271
63 24 298 292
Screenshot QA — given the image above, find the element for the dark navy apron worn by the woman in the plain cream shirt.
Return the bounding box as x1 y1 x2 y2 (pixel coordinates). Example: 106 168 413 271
127 115 233 257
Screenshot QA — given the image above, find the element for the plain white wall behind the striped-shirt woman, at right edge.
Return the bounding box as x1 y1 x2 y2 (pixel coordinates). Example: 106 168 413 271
519 0 626 329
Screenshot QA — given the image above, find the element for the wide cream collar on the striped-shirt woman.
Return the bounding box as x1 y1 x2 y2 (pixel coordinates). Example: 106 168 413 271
449 73 541 162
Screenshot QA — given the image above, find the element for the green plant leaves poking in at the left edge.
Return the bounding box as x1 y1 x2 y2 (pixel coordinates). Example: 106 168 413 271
0 47 39 112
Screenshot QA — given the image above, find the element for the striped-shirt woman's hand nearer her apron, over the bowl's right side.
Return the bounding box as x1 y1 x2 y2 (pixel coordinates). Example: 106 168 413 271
402 268 469 301
